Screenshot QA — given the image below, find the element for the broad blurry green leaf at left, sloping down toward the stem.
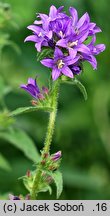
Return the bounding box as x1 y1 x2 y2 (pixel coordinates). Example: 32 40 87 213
0 128 40 162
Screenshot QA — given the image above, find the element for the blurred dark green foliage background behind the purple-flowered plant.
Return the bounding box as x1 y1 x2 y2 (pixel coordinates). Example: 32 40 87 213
0 0 110 199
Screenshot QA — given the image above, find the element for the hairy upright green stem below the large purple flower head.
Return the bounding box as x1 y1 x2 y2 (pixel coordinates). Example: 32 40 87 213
31 80 60 200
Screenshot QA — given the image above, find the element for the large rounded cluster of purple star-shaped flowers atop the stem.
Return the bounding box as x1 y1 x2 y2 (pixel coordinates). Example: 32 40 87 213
25 6 105 80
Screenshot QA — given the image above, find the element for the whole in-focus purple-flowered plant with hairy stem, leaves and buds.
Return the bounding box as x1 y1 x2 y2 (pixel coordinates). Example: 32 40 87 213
10 6 105 200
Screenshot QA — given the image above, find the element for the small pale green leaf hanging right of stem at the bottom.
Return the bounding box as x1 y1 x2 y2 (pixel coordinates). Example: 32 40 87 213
51 171 63 199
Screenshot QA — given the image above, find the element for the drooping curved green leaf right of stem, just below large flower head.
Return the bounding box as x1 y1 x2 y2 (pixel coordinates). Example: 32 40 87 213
62 77 87 100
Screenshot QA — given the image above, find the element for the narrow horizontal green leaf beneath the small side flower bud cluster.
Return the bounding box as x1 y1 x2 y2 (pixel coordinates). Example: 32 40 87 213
8 106 52 117
